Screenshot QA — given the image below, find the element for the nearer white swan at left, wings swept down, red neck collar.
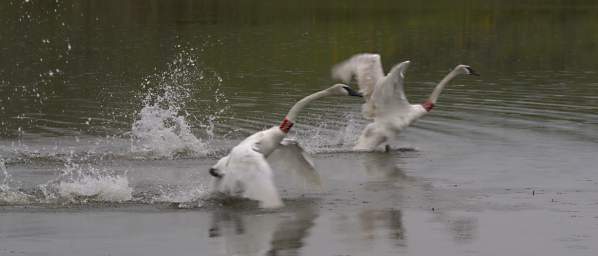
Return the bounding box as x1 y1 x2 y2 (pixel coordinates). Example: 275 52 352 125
209 84 362 208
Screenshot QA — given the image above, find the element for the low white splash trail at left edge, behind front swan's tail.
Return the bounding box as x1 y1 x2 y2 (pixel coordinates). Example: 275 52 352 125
0 158 210 208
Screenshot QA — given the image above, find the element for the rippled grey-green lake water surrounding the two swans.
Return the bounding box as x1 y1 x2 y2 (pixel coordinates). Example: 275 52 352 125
0 0 598 255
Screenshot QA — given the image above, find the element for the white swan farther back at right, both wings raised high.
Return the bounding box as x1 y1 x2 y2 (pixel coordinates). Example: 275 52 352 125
332 53 479 151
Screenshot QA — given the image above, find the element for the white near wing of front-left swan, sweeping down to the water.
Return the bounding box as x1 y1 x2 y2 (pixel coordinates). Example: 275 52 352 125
220 145 283 208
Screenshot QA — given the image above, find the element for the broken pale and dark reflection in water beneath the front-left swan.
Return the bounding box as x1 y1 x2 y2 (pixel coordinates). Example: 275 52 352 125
209 206 318 255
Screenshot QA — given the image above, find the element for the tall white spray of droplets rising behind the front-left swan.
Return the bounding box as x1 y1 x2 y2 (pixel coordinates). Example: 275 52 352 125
131 50 228 158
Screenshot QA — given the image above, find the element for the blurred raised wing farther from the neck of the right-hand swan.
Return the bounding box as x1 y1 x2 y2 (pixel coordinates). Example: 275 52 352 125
332 53 384 102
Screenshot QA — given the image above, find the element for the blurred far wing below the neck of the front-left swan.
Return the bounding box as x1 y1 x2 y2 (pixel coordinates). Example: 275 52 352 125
268 139 321 188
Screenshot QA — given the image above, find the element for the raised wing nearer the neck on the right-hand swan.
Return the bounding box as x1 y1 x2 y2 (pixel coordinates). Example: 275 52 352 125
372 61 409 117
